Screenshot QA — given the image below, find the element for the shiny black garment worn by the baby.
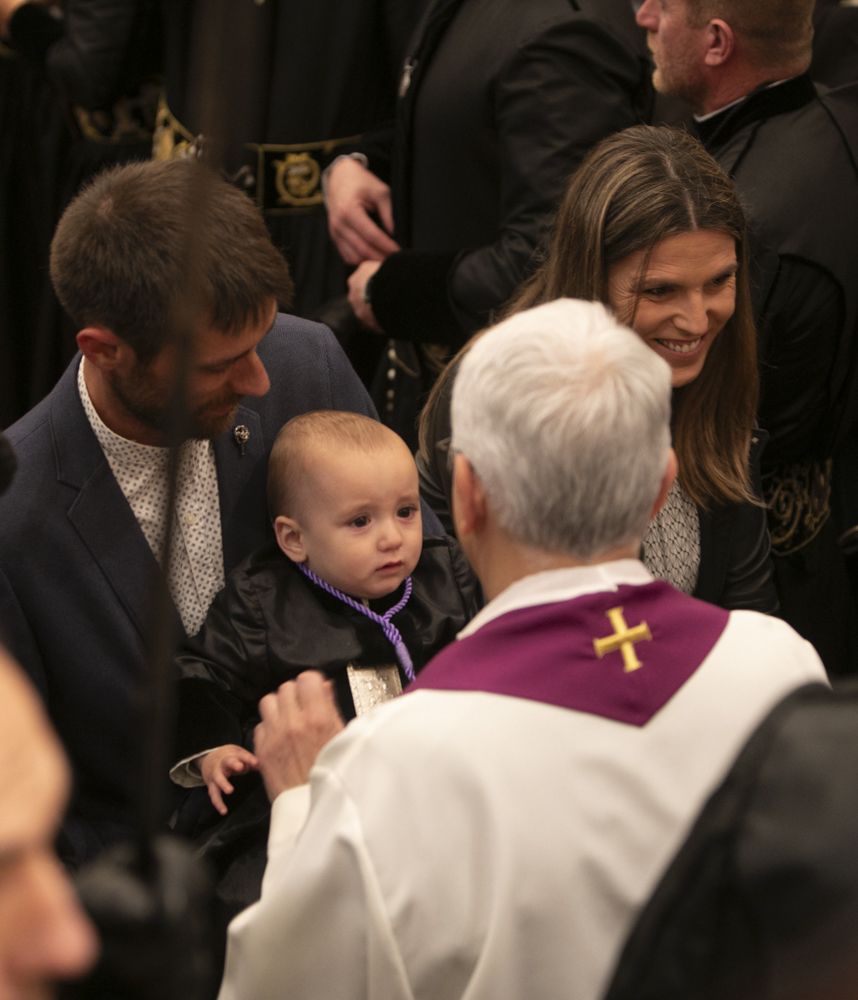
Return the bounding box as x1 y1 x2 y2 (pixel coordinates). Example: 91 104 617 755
171 538 477 759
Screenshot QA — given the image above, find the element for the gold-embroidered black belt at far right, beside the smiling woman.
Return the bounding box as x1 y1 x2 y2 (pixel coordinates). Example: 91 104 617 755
763 458 832 556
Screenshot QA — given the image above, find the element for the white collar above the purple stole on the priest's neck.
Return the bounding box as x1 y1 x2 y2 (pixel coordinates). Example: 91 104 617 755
457 559 653 639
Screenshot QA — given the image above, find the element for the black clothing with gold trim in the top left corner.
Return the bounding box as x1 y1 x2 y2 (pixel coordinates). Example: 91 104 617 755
0 0 160 426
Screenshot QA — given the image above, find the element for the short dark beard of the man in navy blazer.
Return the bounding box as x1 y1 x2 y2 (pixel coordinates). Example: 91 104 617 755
110 363 241 440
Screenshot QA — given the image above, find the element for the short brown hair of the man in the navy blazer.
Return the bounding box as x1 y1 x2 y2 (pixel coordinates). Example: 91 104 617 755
51 160 292 362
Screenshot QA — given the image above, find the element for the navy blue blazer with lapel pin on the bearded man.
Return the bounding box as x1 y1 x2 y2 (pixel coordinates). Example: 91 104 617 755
0 315 375 864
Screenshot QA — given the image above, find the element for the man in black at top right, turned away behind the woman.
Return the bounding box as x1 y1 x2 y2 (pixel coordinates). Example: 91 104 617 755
637 0 858 673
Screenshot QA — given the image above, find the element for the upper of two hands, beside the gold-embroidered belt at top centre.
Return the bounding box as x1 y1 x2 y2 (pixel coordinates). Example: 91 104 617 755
325 156 399 264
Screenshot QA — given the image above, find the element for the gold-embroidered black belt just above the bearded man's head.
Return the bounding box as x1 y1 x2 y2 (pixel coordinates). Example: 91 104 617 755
152 98 360 214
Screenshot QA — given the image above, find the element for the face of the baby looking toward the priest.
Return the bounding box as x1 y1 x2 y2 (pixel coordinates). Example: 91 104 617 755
290 443 423 598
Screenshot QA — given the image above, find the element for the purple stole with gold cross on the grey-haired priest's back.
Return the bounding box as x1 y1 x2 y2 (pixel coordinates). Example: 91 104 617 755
408 581 729 726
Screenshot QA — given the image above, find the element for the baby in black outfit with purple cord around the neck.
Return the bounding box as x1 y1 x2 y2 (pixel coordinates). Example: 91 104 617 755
170 411 477 815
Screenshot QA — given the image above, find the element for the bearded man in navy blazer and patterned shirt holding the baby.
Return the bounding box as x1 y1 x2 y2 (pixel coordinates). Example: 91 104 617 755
0 161 373 864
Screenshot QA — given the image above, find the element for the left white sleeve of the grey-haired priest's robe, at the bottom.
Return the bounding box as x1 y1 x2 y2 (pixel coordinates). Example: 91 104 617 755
219 766 412 1000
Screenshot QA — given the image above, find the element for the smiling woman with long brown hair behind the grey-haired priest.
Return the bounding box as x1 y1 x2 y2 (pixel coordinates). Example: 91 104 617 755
419 126 777 611
